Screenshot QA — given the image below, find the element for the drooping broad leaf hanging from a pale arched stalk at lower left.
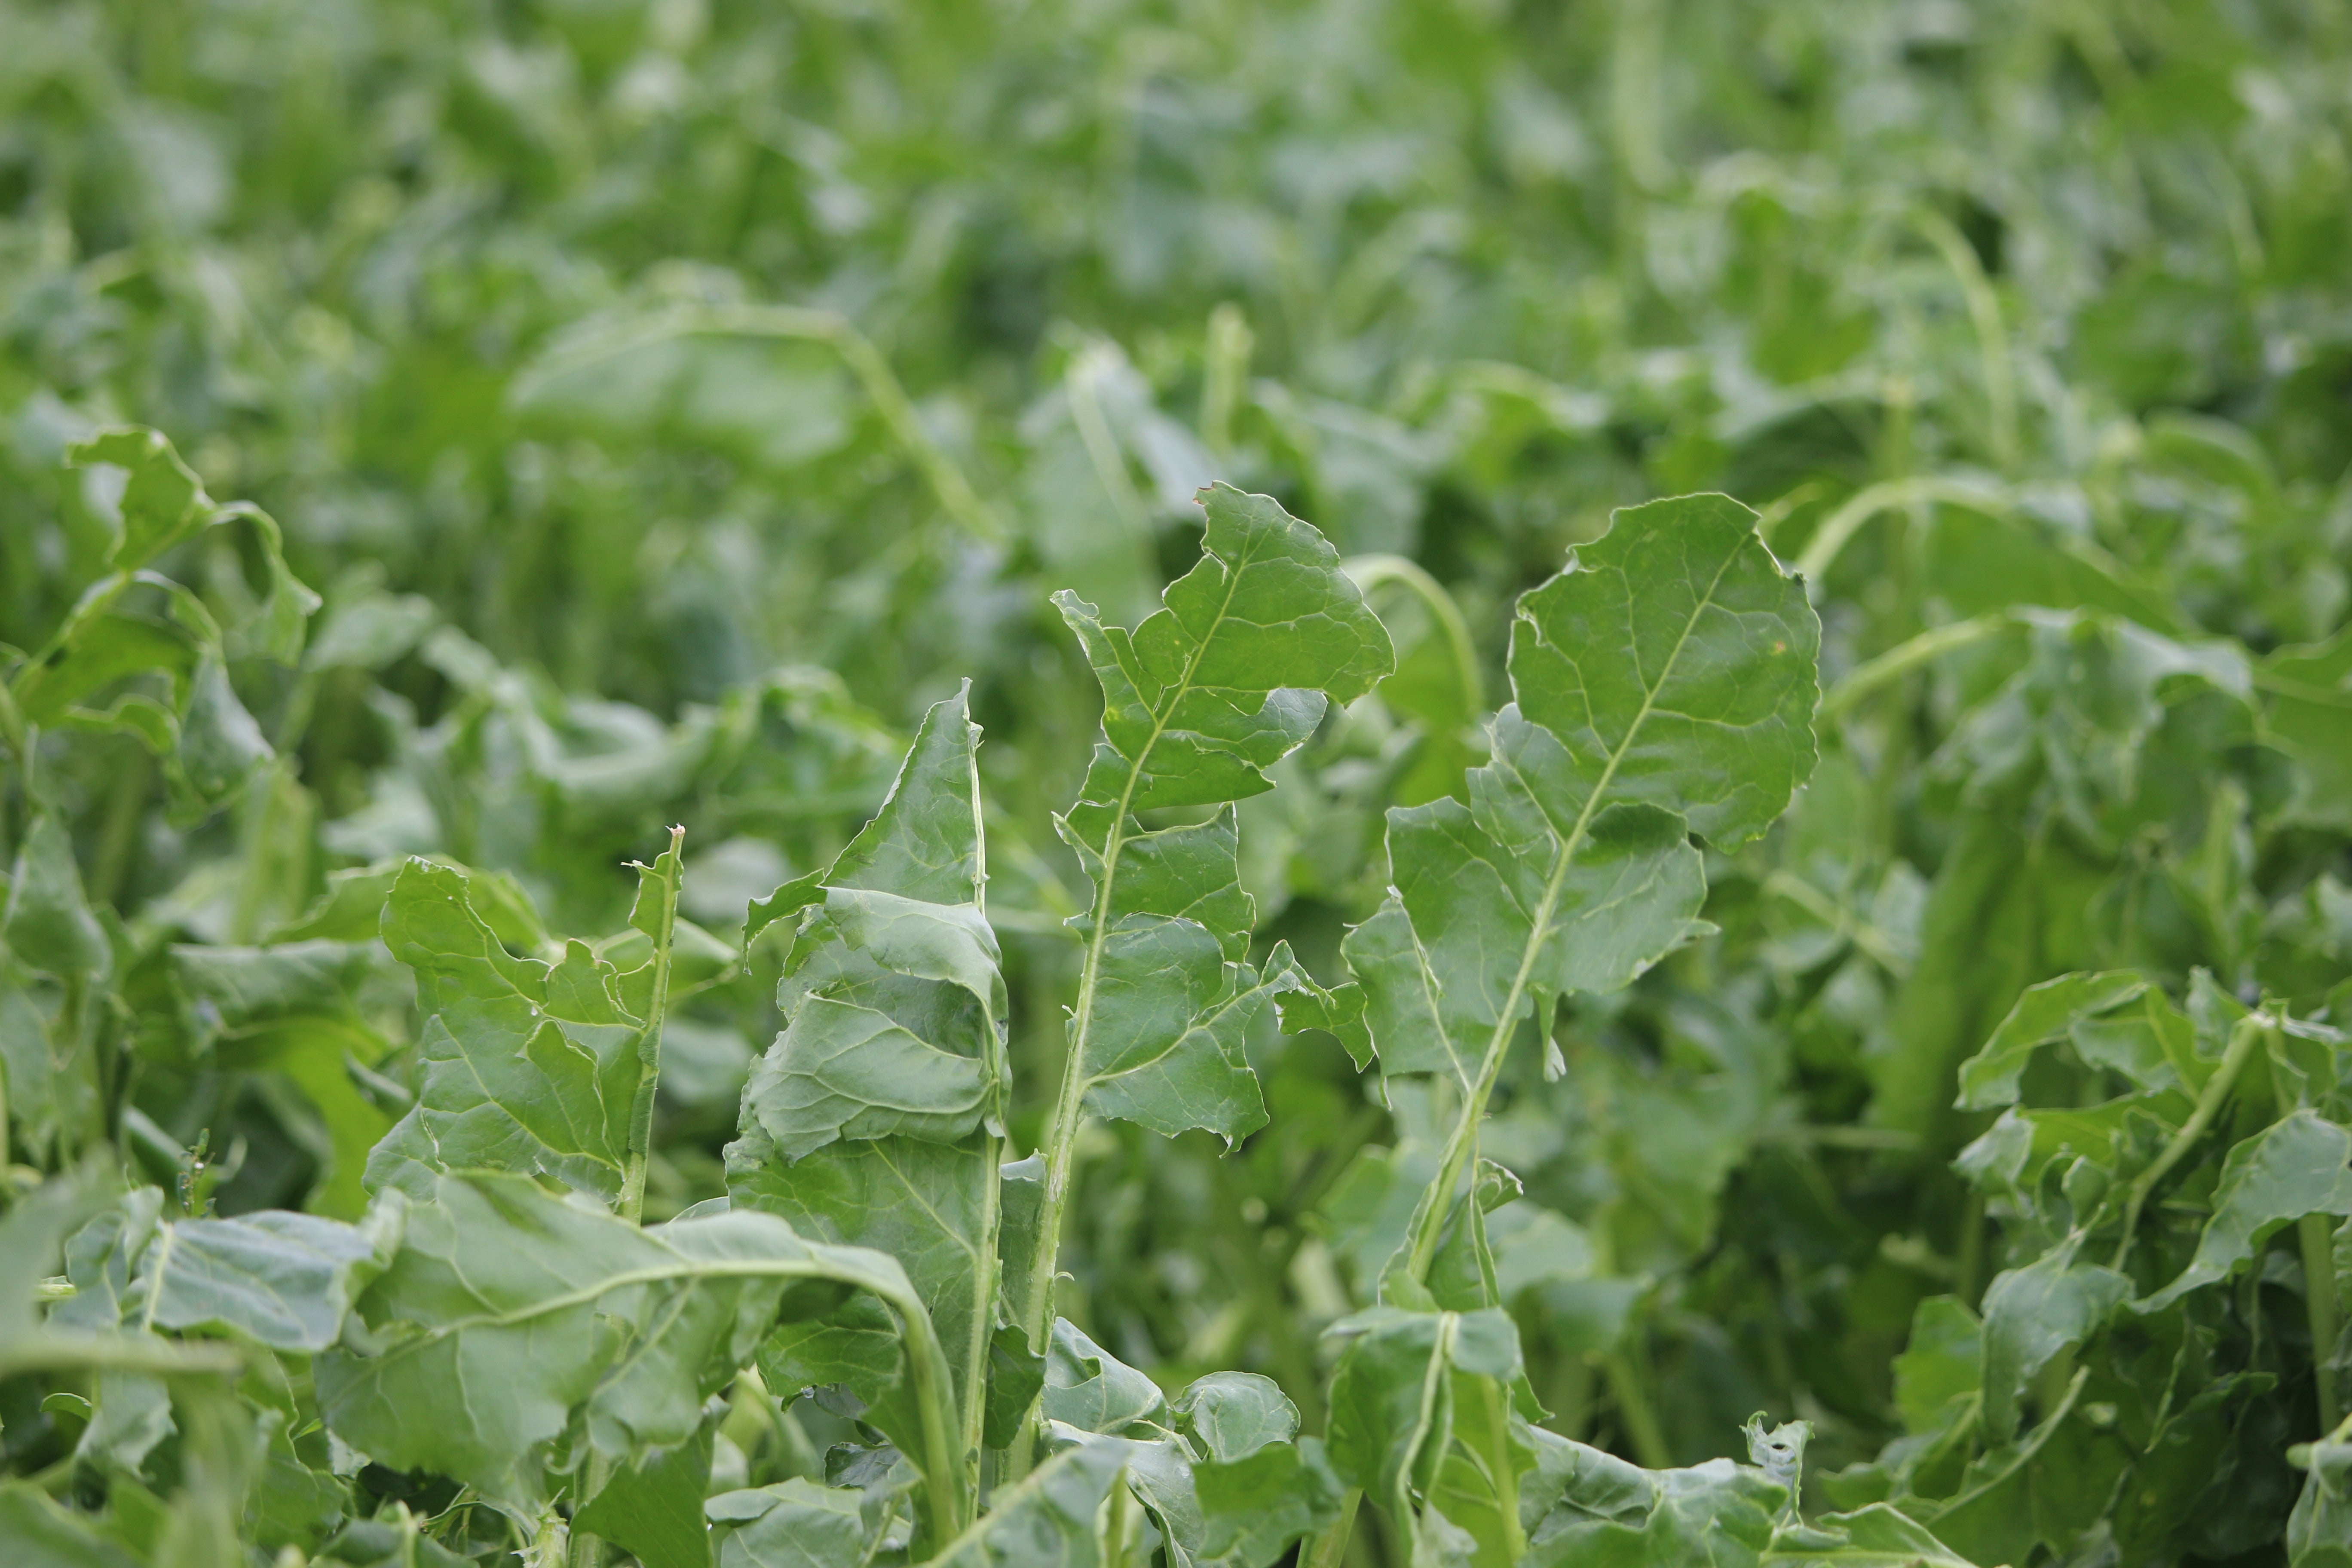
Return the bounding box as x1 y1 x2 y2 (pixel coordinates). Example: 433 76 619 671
318 1173 938 1504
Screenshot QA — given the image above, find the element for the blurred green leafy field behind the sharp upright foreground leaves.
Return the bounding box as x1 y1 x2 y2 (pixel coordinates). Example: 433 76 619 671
0 0 2352 1504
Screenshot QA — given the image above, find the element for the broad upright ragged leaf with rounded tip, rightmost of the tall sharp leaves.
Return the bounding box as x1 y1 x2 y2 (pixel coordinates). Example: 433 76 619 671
1341 496 1820 1300
